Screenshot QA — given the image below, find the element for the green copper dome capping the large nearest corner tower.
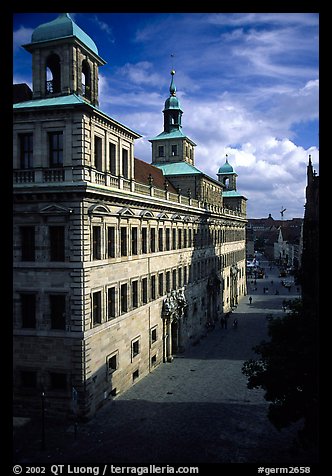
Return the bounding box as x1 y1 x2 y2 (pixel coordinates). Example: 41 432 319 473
31 13 98 55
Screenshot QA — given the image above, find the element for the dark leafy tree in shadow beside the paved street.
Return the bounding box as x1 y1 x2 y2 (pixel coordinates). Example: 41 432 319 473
242 300 319 446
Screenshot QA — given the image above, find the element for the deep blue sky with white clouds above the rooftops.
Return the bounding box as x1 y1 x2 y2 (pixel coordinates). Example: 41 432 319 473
13 13 319 219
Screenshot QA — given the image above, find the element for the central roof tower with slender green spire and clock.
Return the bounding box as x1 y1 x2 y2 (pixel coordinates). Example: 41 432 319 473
149 70 196 165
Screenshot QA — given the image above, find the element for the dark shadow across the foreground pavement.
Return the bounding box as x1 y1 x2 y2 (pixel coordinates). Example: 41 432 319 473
15 396 316 466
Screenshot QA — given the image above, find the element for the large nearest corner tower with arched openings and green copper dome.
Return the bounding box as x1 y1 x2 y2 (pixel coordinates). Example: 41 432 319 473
23 13 106 106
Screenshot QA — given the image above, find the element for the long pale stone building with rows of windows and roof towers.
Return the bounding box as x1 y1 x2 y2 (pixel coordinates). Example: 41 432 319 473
13 14 246 417
